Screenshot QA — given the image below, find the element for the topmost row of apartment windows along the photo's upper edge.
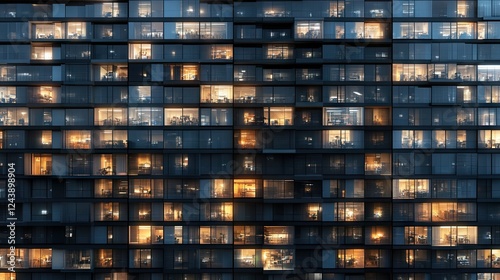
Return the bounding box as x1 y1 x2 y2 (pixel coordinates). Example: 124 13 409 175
0 0 492 19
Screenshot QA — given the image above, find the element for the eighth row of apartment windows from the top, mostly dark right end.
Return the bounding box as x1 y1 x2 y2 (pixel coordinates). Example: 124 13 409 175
0 152 500 176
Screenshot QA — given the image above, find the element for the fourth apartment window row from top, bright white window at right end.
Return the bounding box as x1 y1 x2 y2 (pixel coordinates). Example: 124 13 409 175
0 63 500 85
